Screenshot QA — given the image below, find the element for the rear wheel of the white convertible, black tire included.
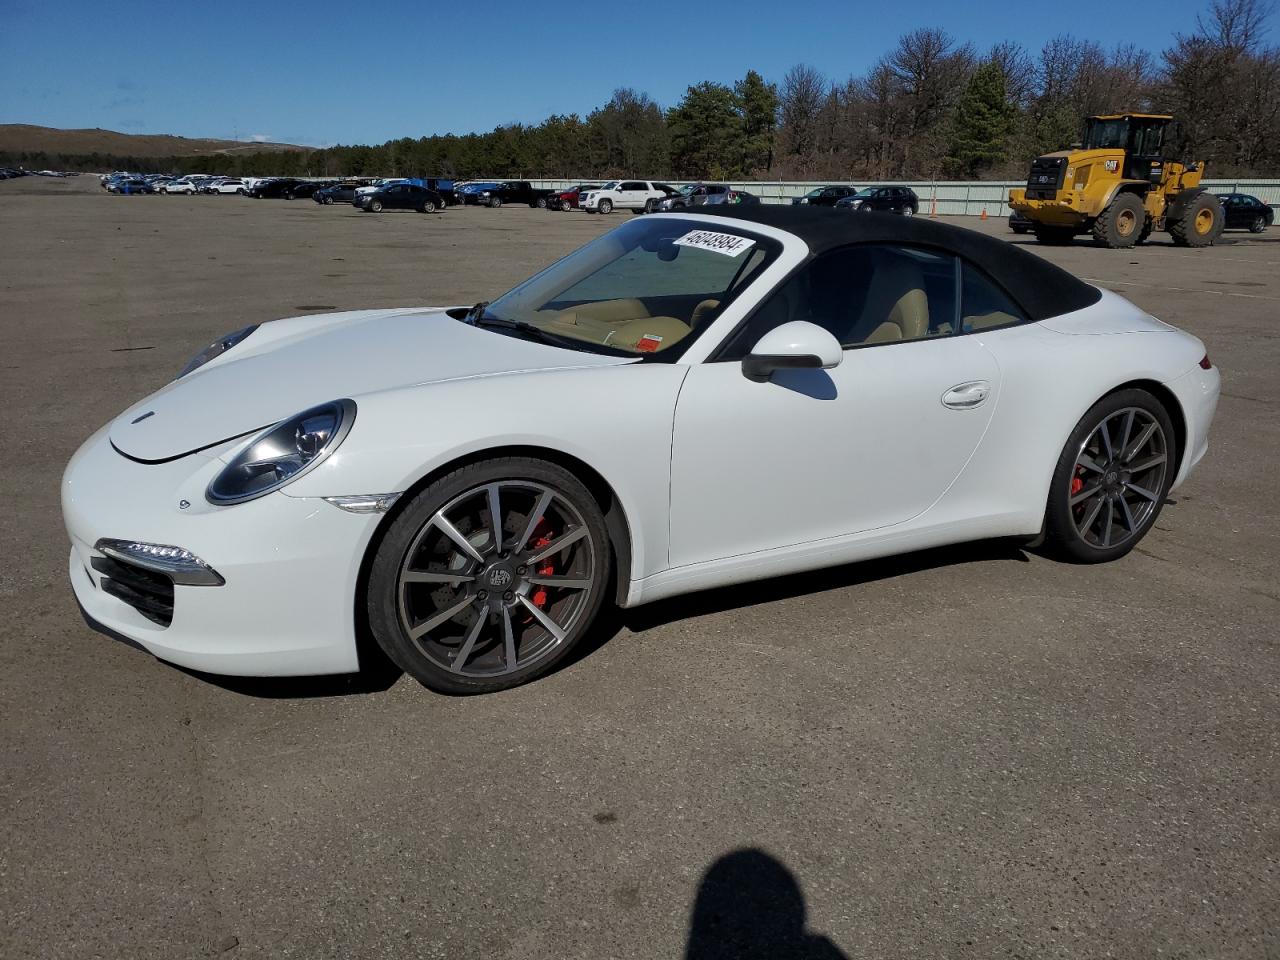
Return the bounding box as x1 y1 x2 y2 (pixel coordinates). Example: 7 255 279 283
1044 389 1178 563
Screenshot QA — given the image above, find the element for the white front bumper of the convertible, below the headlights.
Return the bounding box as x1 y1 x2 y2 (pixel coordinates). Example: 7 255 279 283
61 428 379 676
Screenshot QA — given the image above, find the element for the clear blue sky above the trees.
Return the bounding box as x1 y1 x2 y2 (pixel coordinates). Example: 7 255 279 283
0 0 1280 146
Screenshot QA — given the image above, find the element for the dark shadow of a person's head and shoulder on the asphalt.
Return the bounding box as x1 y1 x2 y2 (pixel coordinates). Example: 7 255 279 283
685 849 849 960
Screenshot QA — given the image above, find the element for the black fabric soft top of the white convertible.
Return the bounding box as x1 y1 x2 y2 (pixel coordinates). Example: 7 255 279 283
682 204 1102 320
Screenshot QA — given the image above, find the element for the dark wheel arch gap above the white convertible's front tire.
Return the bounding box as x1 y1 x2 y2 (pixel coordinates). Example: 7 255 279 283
353 445 632 663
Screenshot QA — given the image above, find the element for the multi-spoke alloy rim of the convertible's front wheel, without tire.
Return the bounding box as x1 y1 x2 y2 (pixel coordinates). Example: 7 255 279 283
396 480 598 678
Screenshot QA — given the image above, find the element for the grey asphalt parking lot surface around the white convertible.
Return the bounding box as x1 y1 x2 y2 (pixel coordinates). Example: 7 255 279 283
0 177 1280 960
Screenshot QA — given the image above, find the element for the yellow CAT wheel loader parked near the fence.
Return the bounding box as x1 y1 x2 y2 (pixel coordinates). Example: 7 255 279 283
1009 114 1224 248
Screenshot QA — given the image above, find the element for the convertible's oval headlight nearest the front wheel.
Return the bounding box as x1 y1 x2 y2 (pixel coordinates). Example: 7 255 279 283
205 399 356 506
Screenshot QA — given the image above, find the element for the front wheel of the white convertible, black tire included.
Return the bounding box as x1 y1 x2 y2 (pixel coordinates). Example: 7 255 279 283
367 457 612 694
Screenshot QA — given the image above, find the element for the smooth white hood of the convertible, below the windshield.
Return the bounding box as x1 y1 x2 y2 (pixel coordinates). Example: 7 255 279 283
111 308 631 461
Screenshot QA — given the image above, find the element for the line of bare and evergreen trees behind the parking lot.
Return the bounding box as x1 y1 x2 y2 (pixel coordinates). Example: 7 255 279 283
6 0 1280 182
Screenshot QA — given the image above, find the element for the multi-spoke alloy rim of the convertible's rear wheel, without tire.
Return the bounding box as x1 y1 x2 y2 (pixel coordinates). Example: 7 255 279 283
1068 407 1169 549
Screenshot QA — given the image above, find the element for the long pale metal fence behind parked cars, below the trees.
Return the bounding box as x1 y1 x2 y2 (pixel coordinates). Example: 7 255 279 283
519 178 1280 216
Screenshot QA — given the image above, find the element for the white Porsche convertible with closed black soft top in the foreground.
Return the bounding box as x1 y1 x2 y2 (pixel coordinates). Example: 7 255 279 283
63 206 1219 692
